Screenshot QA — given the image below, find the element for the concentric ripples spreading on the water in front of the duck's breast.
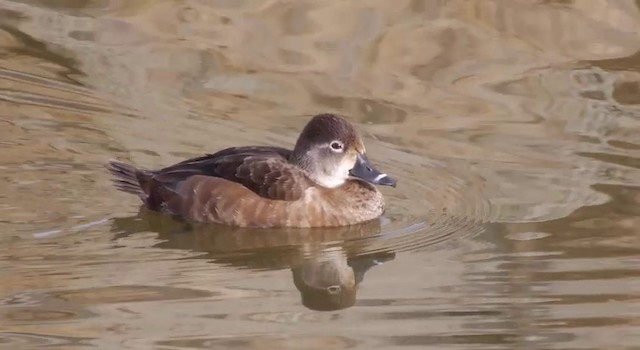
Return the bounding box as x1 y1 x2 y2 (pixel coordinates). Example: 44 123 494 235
348 155 493 253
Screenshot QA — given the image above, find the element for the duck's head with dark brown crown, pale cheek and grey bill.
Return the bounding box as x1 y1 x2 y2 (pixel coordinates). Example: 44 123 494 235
291 114 396 188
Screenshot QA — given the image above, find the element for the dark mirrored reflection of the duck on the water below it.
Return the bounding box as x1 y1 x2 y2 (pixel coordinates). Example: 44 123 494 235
112 208 395 311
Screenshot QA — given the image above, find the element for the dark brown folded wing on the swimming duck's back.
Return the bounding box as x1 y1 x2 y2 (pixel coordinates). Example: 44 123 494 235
148 146 314 201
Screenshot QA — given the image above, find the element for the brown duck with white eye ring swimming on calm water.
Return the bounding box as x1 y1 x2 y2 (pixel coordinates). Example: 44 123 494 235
107 114 397 228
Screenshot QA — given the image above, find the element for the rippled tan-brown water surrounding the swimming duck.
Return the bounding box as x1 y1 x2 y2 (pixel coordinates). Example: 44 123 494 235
0 0 640 349
